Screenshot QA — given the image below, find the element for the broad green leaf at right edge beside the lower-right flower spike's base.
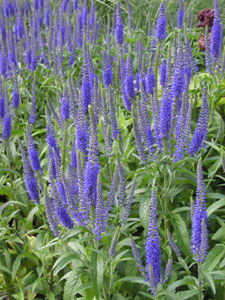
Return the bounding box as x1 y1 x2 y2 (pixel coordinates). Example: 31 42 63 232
203 244 225 271
